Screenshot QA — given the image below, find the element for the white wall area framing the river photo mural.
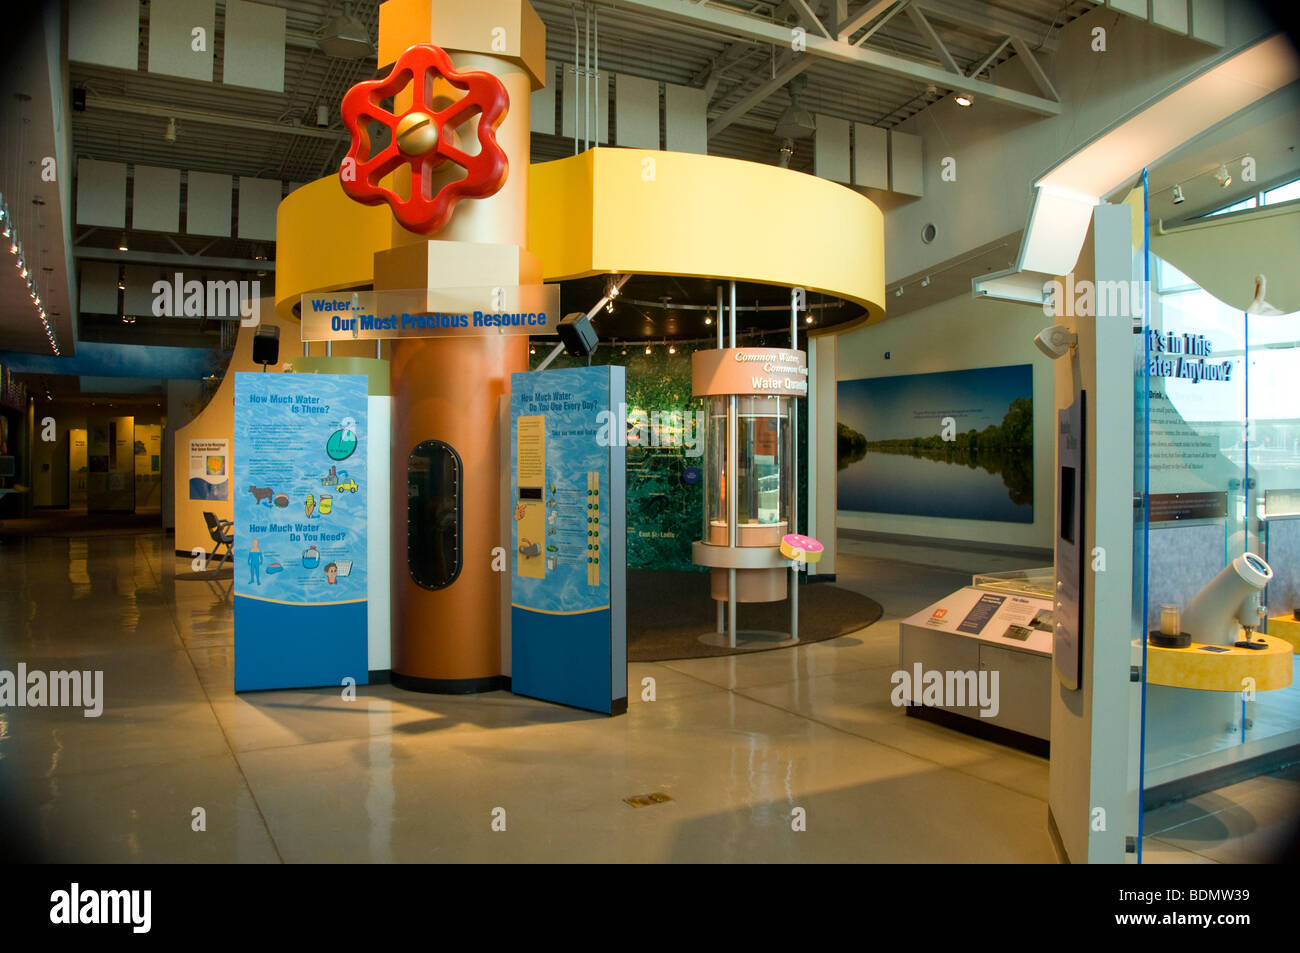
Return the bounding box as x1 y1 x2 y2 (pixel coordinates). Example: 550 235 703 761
836 289 1056 549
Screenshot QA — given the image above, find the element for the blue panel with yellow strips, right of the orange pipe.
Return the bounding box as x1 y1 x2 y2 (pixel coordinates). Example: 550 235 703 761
510 367 628 714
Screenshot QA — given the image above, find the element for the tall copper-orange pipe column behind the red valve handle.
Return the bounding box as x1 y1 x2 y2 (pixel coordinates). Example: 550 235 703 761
374 0 546 693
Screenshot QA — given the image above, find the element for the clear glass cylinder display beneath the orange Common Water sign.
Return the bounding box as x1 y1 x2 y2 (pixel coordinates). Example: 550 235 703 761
703 395 794 546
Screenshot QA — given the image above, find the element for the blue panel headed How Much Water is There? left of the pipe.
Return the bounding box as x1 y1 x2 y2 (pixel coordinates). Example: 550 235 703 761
233 372 366 692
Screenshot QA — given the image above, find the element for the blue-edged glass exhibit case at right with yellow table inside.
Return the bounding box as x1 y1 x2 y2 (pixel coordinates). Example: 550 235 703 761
1132 169 1300 862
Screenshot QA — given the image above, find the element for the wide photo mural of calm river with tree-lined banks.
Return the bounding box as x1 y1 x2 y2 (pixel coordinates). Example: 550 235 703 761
836 364 1034 523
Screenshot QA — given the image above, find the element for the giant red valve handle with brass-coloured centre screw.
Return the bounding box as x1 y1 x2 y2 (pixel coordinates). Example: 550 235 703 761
339 43 510 235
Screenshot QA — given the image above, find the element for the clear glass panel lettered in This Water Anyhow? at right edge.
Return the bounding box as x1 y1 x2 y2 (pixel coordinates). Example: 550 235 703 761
1135 217 1300 863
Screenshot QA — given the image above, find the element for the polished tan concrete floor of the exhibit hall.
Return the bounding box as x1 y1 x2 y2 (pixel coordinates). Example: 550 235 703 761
0 534 1300 862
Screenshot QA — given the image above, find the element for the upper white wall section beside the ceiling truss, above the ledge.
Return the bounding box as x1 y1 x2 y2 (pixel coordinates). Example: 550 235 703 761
885 3 1269 282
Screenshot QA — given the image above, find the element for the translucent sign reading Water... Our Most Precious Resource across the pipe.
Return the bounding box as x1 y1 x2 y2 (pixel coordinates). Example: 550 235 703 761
299 285 563 341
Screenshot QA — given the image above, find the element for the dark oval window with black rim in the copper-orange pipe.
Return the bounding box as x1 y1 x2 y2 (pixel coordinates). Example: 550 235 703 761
407 441 460 589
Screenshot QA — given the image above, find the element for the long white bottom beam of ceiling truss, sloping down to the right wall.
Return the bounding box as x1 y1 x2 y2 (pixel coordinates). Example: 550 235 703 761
597 0 1061 116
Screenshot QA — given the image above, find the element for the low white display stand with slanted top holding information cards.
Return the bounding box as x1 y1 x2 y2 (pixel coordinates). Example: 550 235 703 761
898 571 1052 753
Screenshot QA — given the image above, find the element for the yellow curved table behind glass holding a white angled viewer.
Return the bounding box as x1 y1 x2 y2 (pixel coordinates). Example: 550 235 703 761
1147 631 1295 692
